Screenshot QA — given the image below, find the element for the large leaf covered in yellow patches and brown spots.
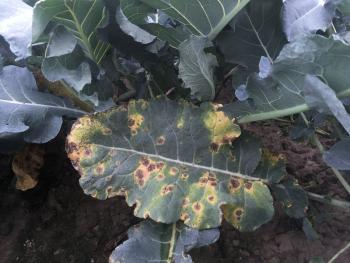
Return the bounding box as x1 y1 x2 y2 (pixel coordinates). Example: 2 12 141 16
67 98 283 231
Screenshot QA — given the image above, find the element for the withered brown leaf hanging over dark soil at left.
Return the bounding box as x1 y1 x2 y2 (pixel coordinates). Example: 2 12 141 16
12 144 44 191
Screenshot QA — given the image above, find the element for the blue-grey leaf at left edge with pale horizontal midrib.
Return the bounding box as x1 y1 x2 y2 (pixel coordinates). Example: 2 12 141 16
0 66 85 154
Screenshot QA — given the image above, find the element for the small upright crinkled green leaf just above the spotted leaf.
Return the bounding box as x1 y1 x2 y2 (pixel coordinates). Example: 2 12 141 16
179 36 218 101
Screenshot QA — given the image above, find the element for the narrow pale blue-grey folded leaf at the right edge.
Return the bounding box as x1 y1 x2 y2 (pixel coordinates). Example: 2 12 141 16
303 75 350 135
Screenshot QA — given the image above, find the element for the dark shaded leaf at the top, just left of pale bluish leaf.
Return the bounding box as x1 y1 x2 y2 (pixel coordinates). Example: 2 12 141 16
216 0 286 72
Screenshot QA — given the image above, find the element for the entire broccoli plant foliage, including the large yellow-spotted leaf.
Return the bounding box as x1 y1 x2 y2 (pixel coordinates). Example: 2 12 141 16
0 0 350 263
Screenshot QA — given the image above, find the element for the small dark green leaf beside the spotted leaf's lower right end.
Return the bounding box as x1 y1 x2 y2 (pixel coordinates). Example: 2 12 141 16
271 178 309 218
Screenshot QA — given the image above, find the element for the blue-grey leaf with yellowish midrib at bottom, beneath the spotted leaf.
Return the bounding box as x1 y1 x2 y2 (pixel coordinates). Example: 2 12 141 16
109 220 220 263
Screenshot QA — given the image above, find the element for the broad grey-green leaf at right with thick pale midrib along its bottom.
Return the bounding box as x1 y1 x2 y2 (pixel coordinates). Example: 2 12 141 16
224 36 350 123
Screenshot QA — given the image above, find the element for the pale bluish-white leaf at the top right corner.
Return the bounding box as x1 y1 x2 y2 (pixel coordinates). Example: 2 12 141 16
283 0 340 41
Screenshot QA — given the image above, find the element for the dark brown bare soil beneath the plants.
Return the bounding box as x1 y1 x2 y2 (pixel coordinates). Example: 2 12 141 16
0 122 350 263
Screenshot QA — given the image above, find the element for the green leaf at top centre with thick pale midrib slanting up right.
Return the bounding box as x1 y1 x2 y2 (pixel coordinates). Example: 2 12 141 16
121 0 249 47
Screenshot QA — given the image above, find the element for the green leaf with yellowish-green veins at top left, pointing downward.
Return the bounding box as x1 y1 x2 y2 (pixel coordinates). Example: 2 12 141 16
32 0 110 64
